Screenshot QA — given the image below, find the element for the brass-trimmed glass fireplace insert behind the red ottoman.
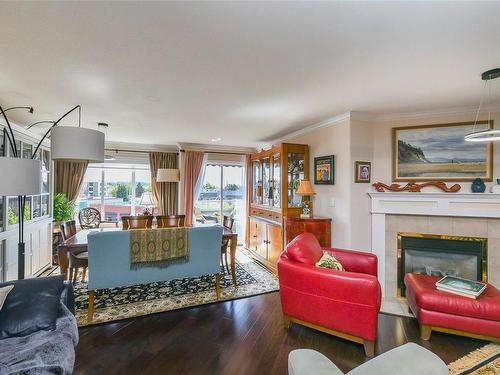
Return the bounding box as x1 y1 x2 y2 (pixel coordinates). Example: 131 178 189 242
398 233 488 297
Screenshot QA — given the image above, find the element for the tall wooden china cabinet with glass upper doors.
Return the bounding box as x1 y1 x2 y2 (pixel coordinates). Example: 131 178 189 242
247 143 309 272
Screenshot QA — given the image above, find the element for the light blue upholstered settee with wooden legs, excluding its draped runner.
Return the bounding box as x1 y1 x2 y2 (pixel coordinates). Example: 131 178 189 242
88 226 222 320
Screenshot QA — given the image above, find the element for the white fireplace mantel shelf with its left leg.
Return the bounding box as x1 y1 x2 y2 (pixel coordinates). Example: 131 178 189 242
368 192 500 295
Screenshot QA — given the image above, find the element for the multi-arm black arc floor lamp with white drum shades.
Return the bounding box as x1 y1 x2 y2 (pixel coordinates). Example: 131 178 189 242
0 105 104 279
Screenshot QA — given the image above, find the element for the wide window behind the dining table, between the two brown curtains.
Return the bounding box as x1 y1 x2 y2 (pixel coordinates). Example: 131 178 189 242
75 163 151 221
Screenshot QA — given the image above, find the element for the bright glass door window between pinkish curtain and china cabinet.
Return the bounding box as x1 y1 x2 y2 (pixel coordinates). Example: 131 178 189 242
194 162 246 242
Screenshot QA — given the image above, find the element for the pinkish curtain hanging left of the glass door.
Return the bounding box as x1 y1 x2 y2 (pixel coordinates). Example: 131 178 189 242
182 151 205 225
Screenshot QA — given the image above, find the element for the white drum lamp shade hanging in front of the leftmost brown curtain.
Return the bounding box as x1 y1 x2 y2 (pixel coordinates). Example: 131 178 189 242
50 126 104 163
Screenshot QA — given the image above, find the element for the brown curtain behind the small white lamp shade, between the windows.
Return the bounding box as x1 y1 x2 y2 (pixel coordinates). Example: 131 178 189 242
149 152 179 215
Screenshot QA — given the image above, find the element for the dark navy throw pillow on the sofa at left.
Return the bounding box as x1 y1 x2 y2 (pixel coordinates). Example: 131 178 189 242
0 275 64 339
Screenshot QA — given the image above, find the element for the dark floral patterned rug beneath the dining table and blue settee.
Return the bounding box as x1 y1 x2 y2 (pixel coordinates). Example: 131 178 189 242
75 261 279 327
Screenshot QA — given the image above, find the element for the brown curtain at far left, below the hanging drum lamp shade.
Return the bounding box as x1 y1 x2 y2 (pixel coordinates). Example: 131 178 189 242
54 160 89 202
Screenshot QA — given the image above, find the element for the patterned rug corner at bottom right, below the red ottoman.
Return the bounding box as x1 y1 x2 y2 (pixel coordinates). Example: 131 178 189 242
448 344 500 375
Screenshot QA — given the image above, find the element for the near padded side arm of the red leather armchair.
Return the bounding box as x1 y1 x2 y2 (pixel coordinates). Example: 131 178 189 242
278 255 381 311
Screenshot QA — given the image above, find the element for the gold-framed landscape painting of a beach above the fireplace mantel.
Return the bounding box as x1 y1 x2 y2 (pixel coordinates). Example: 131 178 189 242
392 121 493 181
